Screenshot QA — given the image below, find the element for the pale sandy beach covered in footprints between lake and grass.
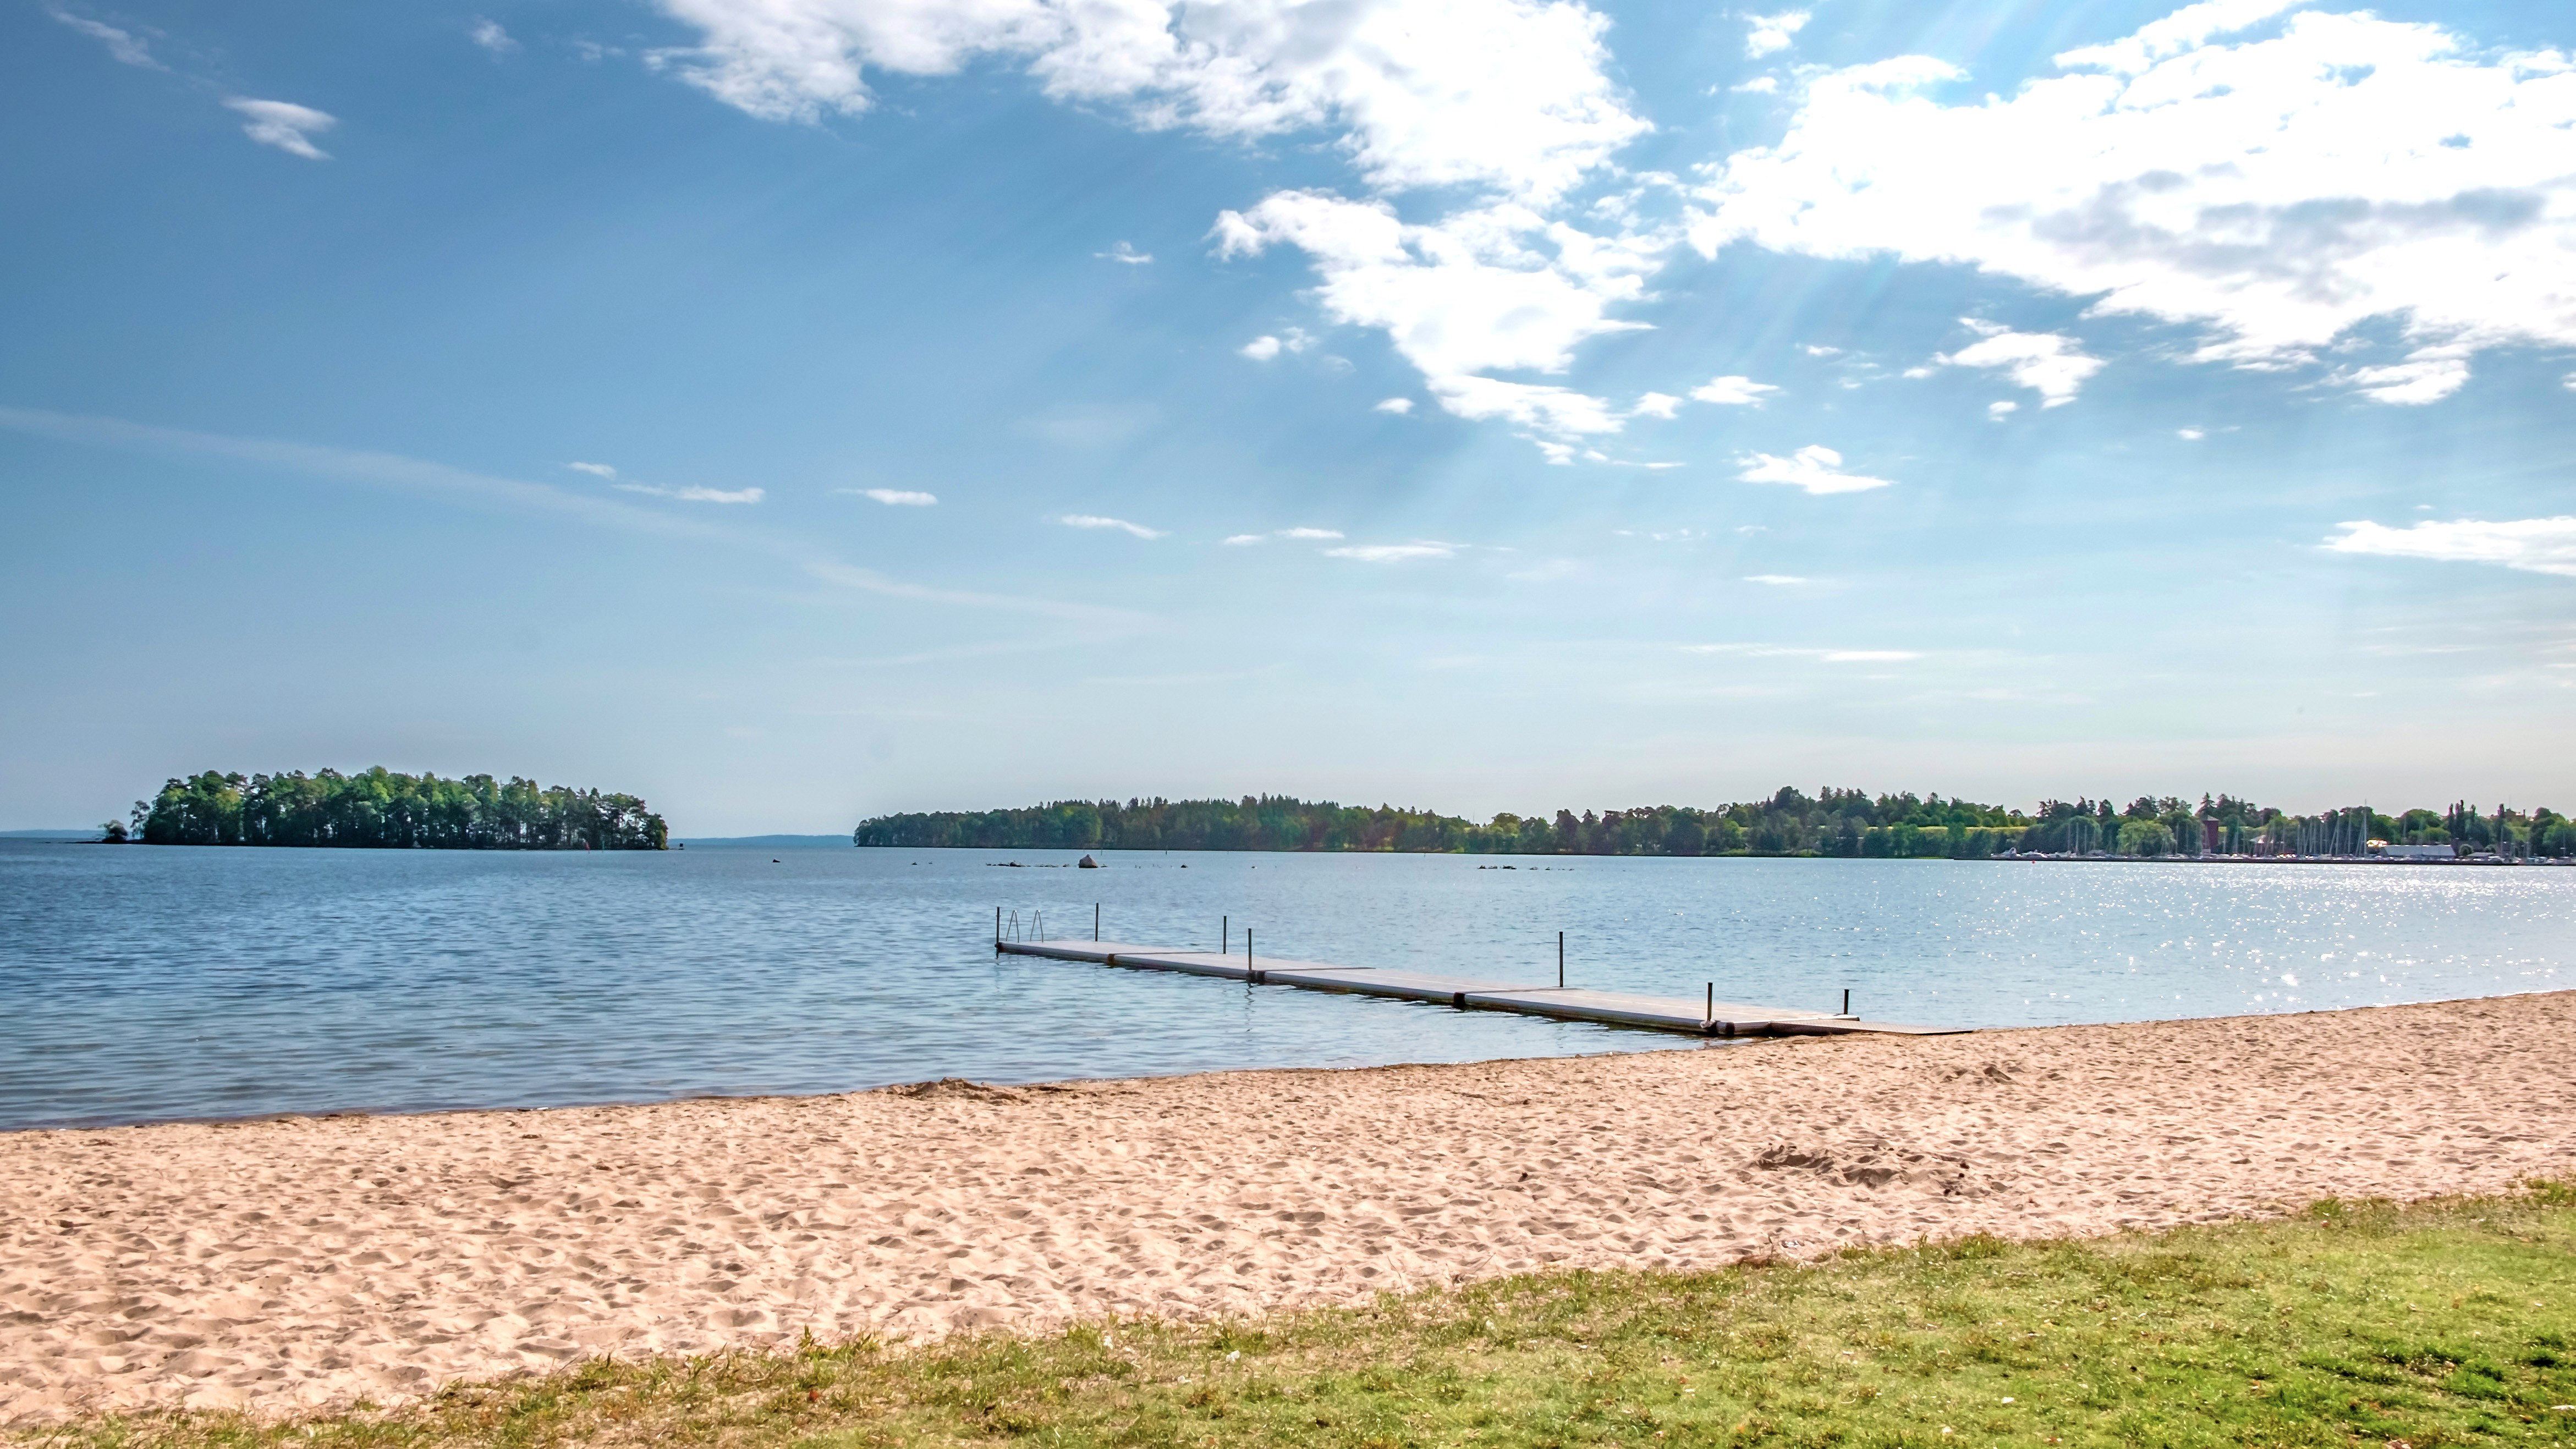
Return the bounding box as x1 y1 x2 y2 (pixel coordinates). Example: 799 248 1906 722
0 992 2576 1423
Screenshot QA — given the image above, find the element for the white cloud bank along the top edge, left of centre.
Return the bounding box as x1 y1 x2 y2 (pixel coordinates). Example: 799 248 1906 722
657 0 1649 199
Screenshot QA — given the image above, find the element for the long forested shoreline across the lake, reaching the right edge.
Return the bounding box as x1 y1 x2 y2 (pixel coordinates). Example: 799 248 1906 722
850 786 2576 859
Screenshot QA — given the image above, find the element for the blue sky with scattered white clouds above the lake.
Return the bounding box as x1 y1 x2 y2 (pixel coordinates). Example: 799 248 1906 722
0 0 2576 833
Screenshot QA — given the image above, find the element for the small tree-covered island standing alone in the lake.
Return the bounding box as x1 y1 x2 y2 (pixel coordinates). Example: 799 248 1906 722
133 766 670 851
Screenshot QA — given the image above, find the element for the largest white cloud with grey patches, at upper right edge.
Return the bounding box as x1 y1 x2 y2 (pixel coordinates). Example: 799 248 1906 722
1690 0 2576 402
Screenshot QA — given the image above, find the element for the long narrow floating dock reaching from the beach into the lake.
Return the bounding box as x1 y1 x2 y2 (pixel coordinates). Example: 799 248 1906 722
992 941 1965 1036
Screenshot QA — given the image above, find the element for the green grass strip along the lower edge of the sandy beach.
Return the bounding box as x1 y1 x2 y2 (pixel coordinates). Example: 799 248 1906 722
29 1183 2576 1449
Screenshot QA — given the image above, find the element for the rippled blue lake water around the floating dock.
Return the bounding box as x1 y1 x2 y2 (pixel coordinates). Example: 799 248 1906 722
0 841 2576 1127
